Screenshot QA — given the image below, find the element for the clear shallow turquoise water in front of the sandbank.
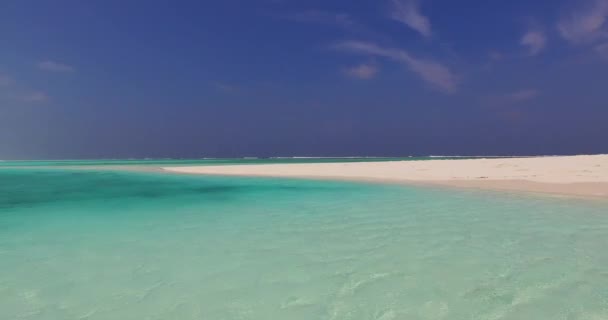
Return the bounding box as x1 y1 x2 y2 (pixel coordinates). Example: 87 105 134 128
0 168 608 320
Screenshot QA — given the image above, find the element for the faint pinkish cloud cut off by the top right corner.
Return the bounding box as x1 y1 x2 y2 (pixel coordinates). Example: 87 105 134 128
557 0 608 44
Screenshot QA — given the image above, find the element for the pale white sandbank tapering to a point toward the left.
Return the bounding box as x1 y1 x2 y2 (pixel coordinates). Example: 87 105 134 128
163 155 608 198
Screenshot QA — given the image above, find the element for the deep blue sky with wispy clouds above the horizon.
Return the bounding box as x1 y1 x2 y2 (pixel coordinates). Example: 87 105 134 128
0 0 608 159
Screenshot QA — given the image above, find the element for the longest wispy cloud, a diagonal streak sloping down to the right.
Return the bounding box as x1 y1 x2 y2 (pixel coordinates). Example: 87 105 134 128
334 41 458 93
